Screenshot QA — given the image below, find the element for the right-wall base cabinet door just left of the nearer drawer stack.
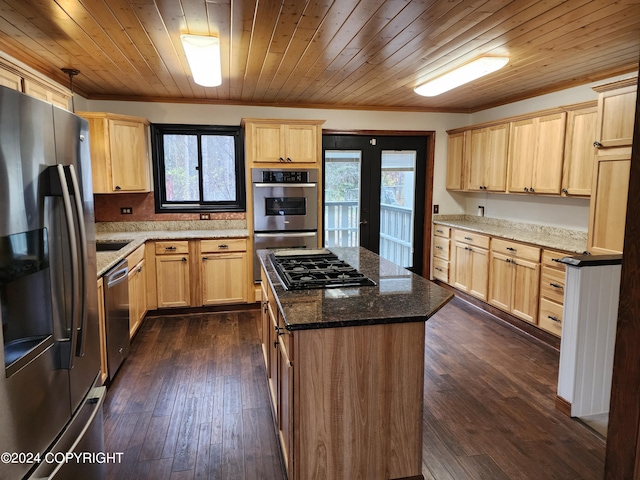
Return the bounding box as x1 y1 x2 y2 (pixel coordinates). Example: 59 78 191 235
511 258 540 323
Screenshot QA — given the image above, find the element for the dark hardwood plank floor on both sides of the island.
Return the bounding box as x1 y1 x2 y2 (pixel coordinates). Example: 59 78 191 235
105 300 605 480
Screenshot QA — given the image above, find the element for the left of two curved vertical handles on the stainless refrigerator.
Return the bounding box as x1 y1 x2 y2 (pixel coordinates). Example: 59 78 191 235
56 164 80 370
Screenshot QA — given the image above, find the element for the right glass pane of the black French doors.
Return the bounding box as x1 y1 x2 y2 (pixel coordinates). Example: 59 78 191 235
380 150 416 268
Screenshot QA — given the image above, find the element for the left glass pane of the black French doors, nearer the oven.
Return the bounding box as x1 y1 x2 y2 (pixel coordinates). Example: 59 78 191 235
324 150 362 247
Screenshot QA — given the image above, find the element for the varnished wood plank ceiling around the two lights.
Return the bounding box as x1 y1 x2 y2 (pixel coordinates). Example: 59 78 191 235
0 0 640 112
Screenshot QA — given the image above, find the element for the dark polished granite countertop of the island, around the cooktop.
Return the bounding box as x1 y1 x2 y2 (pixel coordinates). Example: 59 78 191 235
258 247 453 331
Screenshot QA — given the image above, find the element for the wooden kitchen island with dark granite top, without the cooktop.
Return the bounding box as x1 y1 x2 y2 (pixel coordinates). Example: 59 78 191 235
258 247 452 480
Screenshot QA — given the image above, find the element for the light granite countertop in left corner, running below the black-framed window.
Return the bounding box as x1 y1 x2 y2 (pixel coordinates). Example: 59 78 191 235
96 229 249 278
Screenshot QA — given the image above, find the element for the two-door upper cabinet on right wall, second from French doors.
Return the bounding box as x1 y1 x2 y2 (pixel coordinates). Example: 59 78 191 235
465 123 509 192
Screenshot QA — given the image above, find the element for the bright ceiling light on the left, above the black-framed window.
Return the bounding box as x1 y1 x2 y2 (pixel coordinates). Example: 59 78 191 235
180 34 222 87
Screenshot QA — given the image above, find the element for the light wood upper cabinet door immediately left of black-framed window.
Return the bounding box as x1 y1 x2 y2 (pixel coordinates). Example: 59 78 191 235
109 119 149 192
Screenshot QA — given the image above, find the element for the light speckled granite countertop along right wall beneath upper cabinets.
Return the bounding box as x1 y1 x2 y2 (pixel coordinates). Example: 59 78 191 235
433 215 587 254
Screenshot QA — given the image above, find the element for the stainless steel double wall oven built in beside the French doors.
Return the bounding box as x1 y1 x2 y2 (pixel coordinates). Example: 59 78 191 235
251 168 318 281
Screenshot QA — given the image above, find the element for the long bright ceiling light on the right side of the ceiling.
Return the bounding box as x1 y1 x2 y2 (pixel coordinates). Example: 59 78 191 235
413 57 509 97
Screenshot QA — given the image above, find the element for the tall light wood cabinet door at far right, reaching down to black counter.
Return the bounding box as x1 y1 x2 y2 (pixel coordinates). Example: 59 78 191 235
587 155 631 255
